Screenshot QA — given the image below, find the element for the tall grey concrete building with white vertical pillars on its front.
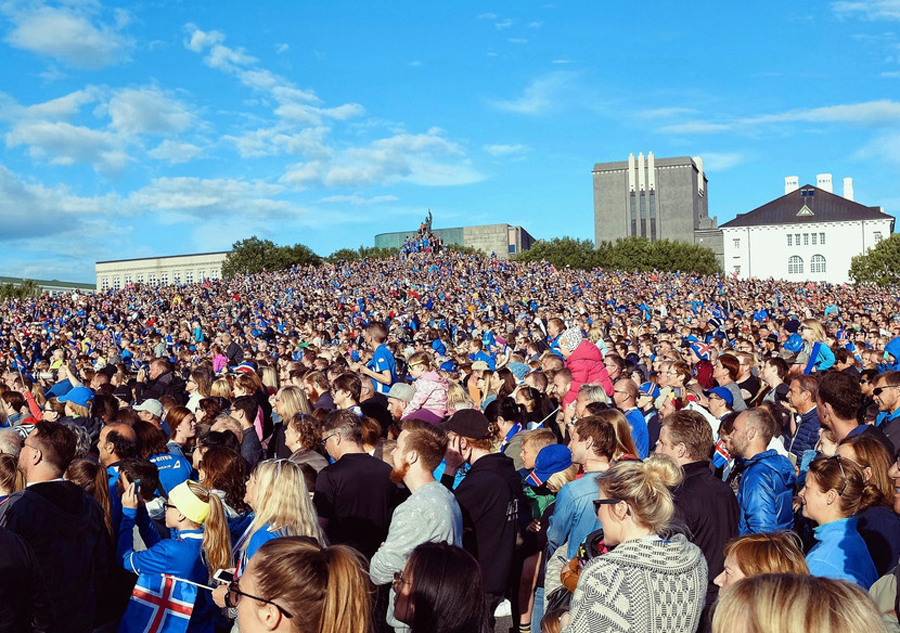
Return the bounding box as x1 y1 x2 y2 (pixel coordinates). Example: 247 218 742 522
594 152 723 263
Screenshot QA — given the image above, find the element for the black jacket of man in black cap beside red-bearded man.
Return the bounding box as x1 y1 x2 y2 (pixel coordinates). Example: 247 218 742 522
441 453 522 594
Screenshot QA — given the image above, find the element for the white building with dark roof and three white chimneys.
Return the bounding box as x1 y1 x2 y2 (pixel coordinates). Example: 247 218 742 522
720 174 894 283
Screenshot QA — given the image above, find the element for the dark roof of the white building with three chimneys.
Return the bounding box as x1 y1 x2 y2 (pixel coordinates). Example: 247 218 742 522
719 185 894 229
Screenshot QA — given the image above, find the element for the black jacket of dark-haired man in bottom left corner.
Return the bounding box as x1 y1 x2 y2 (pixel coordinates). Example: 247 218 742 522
0 481 114 633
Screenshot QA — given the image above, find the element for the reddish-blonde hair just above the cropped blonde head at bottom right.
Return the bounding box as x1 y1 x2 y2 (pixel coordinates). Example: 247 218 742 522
725 532 809 576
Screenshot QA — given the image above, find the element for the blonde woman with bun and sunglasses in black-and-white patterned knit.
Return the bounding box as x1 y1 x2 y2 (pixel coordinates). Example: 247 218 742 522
563 455 707 633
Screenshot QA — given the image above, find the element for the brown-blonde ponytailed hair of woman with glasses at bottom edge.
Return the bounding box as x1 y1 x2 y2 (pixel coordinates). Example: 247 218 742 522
250 536 372 633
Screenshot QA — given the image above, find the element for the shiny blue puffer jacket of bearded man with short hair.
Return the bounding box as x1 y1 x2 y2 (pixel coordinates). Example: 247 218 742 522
738 450 794 536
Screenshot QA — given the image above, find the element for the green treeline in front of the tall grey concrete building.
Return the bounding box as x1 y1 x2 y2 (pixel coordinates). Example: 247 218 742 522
513 237 722 275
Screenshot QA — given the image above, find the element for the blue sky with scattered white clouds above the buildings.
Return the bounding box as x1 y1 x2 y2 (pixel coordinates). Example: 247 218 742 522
0 0 900 282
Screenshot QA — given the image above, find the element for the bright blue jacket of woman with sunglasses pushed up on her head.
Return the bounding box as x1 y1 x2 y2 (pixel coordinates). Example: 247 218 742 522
806 517 878 591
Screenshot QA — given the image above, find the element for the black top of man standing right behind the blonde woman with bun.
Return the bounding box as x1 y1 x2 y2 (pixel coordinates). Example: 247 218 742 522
672 461 741 605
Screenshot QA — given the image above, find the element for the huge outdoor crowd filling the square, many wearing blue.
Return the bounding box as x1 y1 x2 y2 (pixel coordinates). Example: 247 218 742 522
0 246 900 633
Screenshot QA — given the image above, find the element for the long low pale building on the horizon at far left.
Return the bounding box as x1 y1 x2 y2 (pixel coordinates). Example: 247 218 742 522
94 251 229 292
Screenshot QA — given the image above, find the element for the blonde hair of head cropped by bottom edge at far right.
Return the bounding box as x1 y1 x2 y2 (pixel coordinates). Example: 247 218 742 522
712 574 887 633
